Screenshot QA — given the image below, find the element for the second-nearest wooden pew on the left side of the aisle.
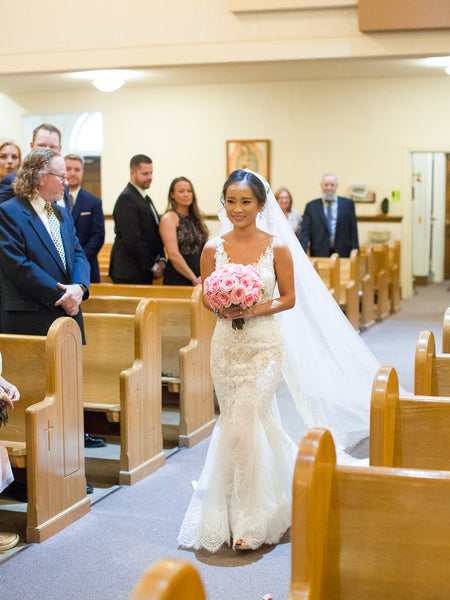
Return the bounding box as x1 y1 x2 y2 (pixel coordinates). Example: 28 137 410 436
83 298 165 485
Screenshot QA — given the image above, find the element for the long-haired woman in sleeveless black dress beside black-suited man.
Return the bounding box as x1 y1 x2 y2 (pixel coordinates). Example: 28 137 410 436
159 177 208 285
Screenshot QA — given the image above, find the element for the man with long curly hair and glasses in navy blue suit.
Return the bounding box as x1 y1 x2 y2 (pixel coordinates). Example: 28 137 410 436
0 148 90 341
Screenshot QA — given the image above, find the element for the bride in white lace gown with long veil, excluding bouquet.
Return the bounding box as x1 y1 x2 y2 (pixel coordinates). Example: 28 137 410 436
178 170 378 552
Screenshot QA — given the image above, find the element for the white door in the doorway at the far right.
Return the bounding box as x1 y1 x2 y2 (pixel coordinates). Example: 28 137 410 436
411 152 446 281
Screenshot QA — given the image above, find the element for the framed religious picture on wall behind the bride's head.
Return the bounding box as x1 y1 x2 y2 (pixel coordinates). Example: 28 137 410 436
227 140 270 183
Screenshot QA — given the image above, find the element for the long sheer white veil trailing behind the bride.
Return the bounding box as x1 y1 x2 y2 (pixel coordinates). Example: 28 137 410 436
219 173 380 449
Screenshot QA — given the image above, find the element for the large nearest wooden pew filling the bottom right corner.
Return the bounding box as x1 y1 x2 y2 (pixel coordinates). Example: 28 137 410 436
289 429 450 600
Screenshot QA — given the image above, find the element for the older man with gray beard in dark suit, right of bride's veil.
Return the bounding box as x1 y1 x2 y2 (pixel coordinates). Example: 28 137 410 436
300 173 359 257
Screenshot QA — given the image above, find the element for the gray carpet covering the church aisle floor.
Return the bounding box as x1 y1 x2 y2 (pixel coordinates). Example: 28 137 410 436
0 283 450 600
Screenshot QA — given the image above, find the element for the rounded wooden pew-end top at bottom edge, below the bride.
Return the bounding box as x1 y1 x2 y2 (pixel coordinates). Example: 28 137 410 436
130 558 206 600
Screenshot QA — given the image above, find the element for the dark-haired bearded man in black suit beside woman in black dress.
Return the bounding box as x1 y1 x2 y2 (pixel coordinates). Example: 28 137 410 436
109 154 165 284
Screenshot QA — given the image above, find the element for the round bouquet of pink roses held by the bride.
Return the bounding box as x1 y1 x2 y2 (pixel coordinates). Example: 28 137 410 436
203 263 264 329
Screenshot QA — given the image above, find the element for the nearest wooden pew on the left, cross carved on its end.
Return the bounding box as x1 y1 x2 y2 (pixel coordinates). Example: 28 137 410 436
0 317 90 542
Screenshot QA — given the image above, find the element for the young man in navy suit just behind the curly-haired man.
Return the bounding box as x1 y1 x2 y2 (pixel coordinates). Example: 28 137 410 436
58 154 105 283
